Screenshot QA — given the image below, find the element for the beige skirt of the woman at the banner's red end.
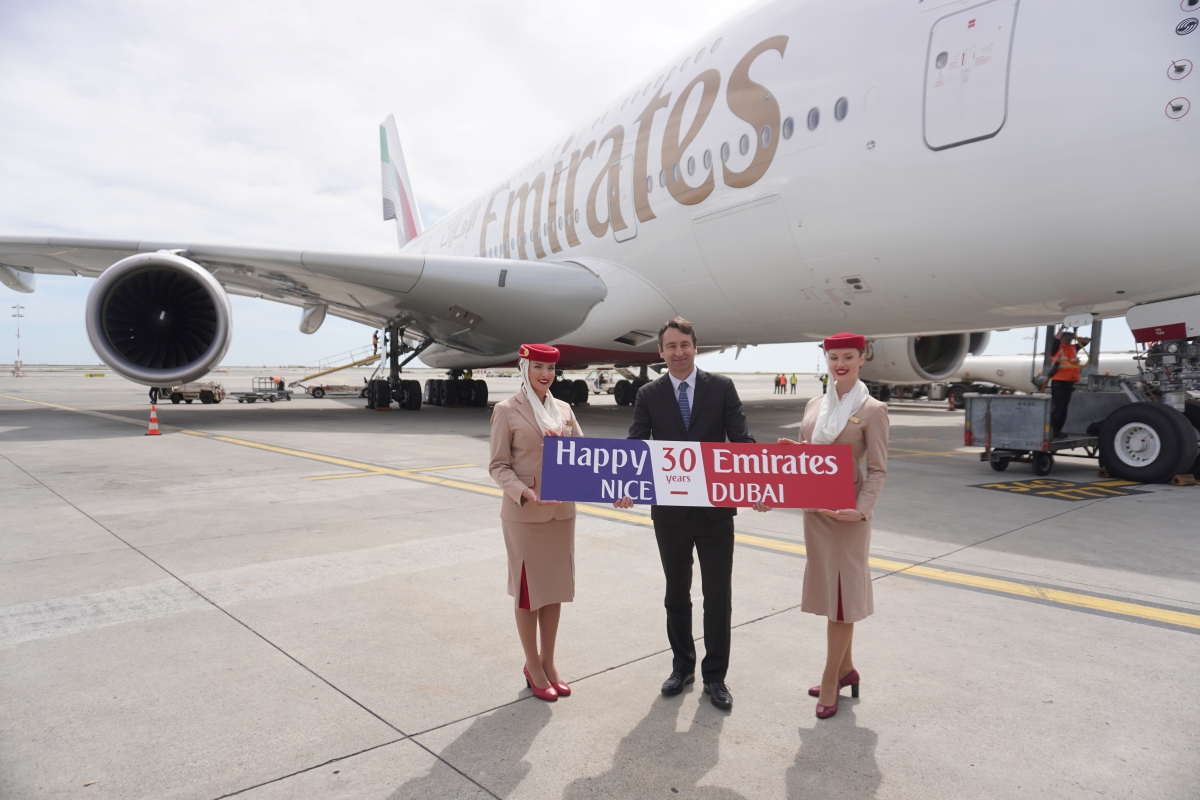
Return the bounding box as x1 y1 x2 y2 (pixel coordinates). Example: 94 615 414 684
800 511 875 622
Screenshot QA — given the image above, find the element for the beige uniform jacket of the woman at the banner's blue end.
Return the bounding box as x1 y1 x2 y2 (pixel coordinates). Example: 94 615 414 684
487 392 583 522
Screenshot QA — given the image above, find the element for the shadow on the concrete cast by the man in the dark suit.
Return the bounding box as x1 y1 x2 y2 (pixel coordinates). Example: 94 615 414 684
563 691 744 800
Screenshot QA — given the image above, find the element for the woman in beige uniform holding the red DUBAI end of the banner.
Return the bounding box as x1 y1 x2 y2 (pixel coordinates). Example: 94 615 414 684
779 333 888 720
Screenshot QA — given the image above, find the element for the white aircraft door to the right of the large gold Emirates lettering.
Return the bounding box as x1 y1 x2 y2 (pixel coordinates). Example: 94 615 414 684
925 0 1019 150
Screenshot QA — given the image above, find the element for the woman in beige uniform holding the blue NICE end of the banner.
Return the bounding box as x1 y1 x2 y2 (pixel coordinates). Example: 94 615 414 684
488 344 583 700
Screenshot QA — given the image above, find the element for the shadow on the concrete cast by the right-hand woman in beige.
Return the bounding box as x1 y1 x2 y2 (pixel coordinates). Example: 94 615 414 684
786 697 883 800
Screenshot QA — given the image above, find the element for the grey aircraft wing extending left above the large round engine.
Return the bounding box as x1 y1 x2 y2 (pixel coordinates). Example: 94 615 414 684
0 236 607 355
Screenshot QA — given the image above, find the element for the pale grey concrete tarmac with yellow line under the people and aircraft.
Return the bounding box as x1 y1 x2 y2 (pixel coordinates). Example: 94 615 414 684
0 369 1200 800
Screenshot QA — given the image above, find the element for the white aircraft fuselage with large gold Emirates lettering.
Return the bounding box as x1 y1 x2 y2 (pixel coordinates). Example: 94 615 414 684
415 0 1200 366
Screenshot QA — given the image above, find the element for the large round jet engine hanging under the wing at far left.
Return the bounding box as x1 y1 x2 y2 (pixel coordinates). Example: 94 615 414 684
86 251 233 386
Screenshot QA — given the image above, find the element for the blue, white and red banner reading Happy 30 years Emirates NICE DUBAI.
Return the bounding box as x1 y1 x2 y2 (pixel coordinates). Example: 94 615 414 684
539 437 854 509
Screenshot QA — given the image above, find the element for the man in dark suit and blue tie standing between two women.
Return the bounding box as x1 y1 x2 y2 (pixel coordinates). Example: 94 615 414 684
614 317 766 709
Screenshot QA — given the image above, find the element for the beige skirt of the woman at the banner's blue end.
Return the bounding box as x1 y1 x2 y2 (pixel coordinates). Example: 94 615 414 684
500 517 575 610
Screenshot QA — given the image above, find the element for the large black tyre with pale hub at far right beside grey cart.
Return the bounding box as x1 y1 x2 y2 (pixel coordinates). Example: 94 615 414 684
1100 403 1196 483
